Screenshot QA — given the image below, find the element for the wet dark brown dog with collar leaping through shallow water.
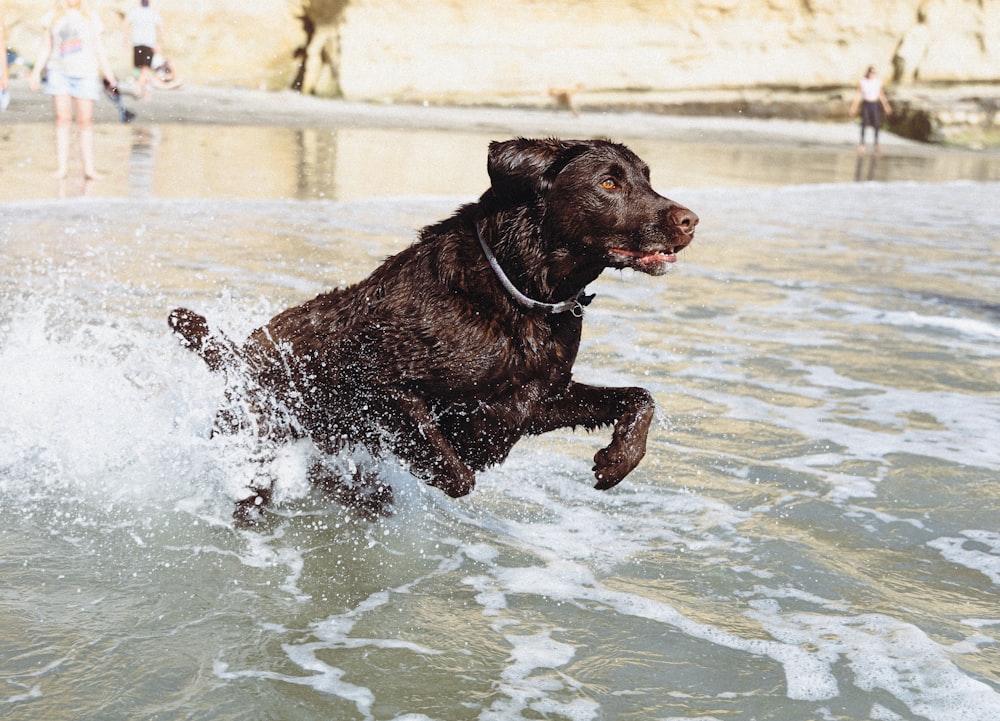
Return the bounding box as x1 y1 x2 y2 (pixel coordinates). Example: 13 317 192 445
169 139 698 517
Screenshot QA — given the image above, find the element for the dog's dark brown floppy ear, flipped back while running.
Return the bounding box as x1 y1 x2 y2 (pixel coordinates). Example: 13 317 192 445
486 138 587 201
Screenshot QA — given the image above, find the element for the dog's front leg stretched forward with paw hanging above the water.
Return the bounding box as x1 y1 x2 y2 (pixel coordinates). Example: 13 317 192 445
531 382 656 491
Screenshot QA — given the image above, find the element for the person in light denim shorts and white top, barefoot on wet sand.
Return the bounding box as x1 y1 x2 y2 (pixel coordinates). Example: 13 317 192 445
29 0 118 180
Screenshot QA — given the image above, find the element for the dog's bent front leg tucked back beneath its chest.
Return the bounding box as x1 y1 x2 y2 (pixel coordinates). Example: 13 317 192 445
387 391 476 498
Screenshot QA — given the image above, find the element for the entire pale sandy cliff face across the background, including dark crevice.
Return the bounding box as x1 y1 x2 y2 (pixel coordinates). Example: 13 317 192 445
6 0 1000 102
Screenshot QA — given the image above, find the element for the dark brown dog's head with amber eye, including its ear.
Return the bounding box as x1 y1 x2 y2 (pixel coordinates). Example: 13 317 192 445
487 138 698 275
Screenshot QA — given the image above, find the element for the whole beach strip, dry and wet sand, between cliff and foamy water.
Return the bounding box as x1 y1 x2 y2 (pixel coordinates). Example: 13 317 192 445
0 80 1000 201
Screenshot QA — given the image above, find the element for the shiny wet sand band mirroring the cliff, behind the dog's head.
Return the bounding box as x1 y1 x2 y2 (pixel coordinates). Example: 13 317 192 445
0 123 1000 200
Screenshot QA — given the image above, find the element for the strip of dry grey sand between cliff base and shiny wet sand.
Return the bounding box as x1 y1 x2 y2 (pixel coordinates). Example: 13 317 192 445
0 79 962 155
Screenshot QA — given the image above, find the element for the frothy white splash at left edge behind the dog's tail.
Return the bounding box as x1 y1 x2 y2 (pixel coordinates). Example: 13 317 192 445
0 309 220 501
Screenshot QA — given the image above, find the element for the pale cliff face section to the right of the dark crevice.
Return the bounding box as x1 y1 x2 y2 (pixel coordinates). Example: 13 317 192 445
322 0 1000 100
